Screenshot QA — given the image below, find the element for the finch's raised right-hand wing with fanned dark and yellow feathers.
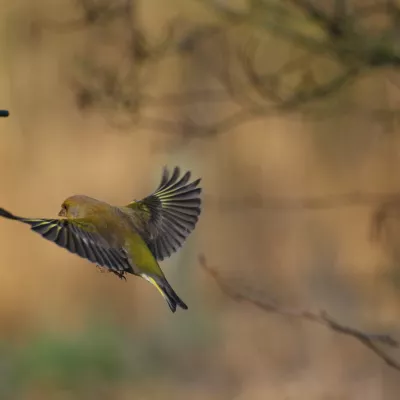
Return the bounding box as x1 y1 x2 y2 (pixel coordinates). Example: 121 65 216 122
127 167 201 261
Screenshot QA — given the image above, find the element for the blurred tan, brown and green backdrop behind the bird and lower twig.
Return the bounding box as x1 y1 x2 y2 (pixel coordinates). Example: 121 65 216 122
0 0 400 400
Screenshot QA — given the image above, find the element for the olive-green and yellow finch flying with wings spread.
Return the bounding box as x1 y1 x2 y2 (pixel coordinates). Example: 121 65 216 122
0 167 201 312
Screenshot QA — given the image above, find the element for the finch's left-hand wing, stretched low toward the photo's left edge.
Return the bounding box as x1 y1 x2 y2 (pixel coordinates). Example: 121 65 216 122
0 208 133 275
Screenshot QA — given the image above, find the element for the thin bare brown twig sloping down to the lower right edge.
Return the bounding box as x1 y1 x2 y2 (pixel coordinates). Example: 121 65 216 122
199 255 400 371
